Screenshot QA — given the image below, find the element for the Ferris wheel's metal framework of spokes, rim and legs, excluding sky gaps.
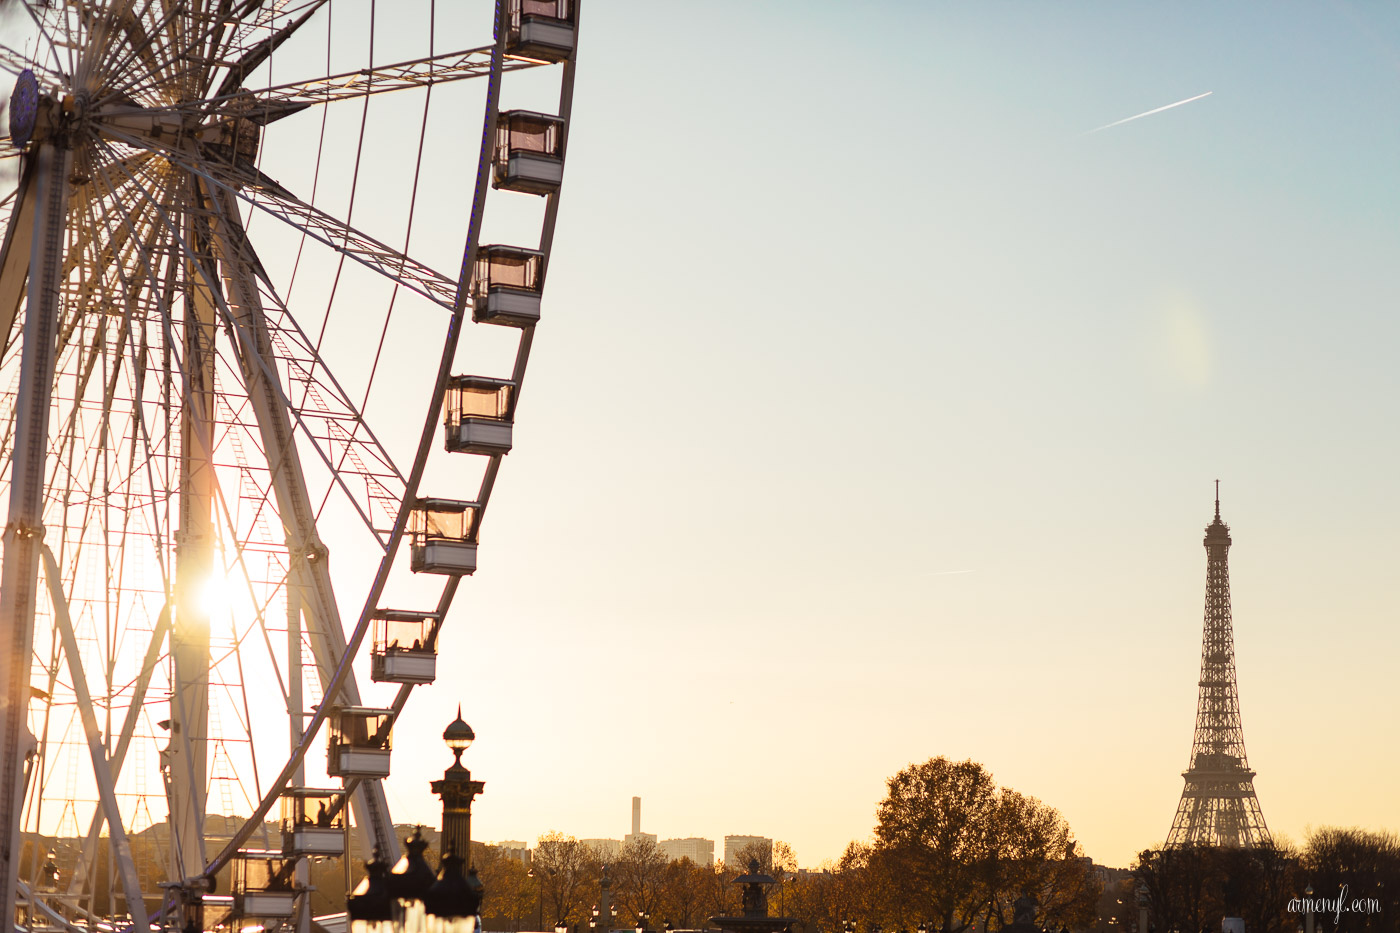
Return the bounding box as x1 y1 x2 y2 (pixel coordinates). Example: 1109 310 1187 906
0 0 580 932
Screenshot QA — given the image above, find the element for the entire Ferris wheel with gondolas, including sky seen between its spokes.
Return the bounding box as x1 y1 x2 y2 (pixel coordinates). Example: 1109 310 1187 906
0 0 578 933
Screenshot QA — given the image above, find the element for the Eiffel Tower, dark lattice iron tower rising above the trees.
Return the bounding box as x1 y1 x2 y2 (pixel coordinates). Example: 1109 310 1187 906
1166 479 1271 849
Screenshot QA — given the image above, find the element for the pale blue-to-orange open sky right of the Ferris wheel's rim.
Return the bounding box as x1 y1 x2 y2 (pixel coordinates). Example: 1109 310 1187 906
369 0 1400 866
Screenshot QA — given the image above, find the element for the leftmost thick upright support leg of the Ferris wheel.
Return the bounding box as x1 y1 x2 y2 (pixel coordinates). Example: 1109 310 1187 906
0 141 73 933
